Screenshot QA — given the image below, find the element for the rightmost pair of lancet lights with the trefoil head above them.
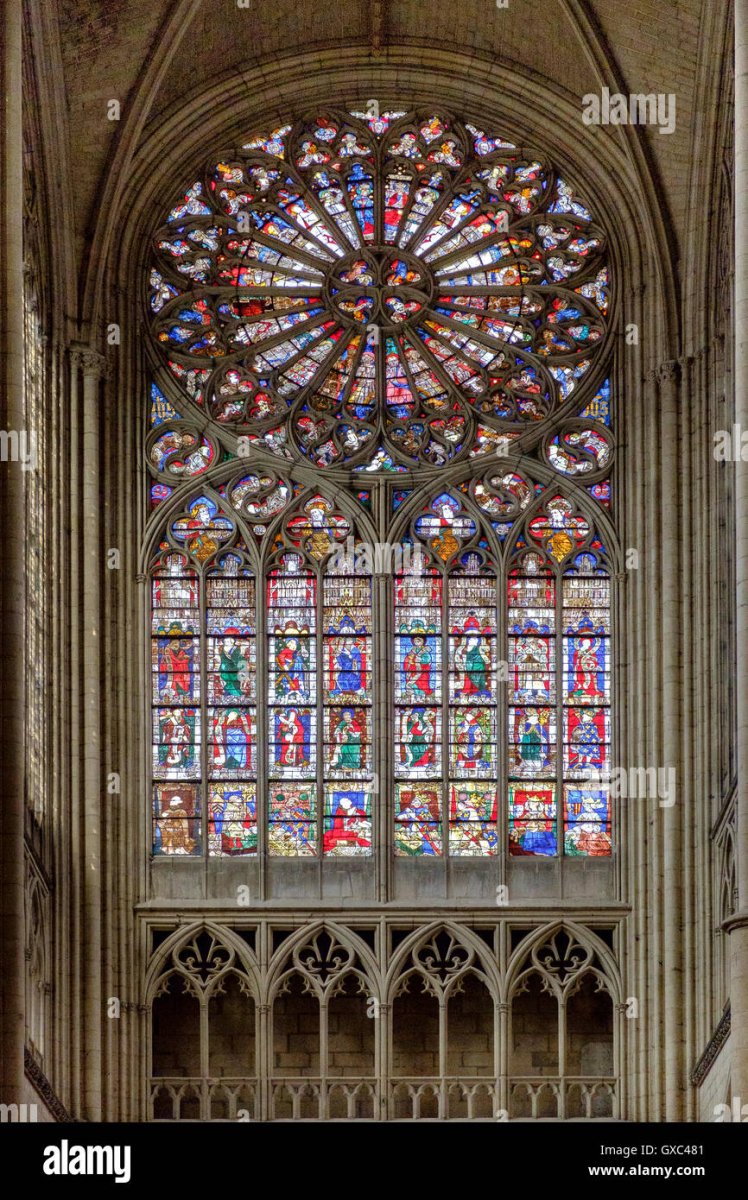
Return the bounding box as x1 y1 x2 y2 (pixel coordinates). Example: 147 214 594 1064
508 496 611 857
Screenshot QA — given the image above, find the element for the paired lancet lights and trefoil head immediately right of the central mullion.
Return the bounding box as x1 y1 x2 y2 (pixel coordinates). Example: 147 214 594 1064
394 492 499 857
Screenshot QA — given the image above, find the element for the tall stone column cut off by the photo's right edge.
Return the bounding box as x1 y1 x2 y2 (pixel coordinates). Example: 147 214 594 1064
728 0 748 1104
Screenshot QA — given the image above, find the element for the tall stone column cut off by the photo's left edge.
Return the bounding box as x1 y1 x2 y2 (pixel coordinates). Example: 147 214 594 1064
0 0 25 1104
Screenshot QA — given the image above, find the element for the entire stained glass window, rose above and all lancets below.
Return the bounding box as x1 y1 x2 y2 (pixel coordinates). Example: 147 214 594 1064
145 110 615 859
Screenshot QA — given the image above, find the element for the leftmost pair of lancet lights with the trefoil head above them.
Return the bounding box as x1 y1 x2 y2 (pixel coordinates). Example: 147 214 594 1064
151 496 257 856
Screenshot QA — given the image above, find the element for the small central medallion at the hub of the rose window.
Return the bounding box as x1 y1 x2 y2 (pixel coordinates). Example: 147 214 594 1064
327 250 433 328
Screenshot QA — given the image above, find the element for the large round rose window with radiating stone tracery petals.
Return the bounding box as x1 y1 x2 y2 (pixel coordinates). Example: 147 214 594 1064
150 112 609 469
